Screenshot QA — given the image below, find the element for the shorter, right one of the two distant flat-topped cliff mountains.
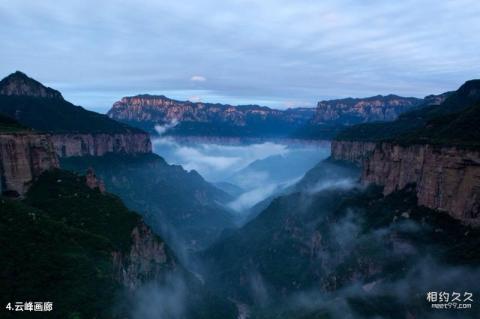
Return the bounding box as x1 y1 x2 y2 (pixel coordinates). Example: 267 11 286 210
312 95 423 125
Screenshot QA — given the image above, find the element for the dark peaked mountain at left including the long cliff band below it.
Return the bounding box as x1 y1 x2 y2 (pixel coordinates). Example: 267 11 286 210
0 71 151 157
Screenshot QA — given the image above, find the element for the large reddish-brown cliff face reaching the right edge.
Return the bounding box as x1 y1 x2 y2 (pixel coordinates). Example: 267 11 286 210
362 143 480 223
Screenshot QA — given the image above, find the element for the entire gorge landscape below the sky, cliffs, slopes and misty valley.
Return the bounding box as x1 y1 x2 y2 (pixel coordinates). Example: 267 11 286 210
0 72 480 319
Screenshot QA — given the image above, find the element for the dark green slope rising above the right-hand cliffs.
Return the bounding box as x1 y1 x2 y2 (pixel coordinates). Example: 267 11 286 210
335 80 480 147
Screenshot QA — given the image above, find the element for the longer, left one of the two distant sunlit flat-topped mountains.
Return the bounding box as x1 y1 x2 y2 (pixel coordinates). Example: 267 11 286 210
107 95 314 137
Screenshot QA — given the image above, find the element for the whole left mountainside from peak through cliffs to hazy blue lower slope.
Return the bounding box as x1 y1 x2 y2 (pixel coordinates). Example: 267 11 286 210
0 72 237 249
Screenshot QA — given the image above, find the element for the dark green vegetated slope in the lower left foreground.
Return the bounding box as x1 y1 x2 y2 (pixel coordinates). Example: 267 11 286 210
0 170 140 318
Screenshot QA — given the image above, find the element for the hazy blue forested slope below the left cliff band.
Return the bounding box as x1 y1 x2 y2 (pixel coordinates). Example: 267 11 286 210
60 154 234 251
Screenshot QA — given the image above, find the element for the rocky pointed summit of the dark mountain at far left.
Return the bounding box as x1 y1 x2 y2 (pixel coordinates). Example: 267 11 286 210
0 71 63 99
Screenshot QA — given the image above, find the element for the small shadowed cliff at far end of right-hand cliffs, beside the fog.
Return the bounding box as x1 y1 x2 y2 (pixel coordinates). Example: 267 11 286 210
331 141 375 166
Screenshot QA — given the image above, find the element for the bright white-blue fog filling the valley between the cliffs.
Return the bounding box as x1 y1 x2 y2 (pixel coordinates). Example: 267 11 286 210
153 134 330 213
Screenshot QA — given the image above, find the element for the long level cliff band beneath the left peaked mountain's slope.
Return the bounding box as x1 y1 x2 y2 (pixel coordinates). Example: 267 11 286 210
52 133 152 157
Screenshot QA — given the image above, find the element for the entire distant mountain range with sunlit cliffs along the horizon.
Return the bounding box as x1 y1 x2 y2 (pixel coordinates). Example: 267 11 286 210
107 95 441 139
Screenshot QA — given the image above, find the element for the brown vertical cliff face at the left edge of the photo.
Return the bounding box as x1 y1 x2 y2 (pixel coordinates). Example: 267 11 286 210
0 133 59 196
